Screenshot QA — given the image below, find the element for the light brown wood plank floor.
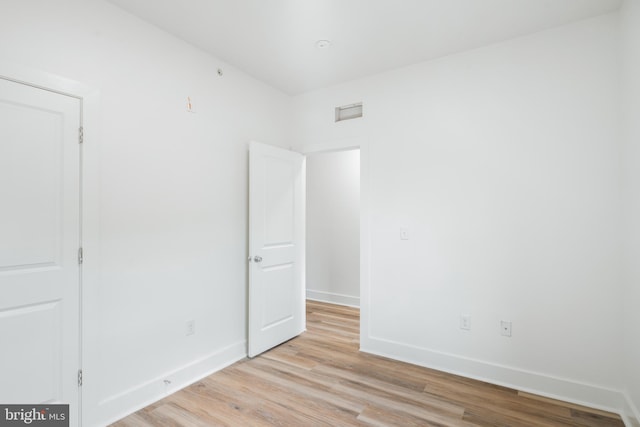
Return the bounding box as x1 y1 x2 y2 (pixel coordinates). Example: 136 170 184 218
113 301 623 427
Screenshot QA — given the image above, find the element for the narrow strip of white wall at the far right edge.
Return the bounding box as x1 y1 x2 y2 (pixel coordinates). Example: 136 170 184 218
621 0 640 420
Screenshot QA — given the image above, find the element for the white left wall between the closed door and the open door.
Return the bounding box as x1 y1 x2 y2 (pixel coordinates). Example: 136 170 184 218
0 0 290 425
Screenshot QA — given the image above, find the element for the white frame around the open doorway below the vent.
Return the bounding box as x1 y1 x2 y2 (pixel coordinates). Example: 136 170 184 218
299 136 371 351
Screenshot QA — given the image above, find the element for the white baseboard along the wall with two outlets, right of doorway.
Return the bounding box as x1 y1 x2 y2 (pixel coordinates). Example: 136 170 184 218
360 337 637 425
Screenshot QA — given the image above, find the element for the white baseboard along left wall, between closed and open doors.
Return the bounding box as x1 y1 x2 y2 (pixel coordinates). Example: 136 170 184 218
97 341 247 425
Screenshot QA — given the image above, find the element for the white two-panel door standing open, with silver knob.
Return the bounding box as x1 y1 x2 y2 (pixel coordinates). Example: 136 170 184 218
248 142 305 357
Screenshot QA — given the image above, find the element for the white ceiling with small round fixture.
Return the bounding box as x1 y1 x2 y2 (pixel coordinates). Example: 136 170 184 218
109 0 621 95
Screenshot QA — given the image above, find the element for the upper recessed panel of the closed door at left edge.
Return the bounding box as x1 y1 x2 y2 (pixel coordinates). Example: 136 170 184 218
0 102 63 270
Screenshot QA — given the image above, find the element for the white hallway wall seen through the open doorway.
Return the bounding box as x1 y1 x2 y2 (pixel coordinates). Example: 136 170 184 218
306 150 360 306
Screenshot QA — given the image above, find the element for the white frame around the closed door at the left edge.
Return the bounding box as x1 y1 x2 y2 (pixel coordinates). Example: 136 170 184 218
0 60 100 425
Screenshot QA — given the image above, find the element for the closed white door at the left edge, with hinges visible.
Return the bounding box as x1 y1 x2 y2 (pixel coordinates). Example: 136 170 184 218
0 78 80 425
